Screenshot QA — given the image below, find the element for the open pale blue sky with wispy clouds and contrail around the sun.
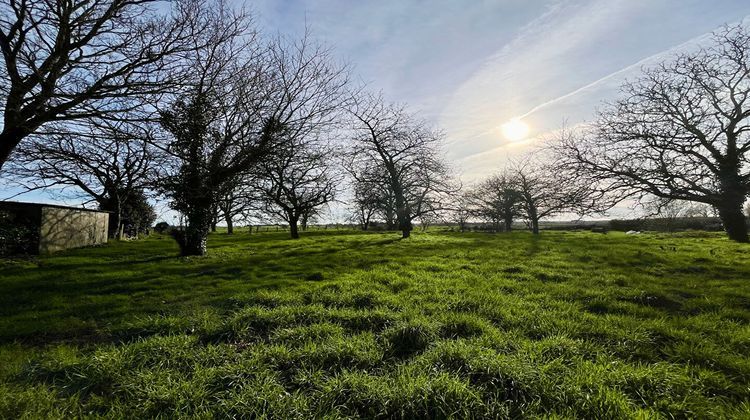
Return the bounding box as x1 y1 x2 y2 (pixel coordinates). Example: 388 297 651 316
0 0 750 220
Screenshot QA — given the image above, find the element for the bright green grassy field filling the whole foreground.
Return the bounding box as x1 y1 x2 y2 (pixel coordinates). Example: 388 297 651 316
0 232 750 418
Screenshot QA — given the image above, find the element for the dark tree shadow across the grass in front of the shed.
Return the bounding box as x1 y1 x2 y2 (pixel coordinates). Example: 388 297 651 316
0 231 478 343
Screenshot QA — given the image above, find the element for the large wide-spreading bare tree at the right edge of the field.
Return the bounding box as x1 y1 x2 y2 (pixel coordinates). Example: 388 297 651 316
556 27 750 242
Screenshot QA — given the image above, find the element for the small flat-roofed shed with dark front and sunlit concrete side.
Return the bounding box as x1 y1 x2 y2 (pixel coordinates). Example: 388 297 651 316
0 201 109 254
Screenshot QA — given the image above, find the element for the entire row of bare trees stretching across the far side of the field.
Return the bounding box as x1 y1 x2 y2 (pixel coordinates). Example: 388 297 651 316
0 0 750 249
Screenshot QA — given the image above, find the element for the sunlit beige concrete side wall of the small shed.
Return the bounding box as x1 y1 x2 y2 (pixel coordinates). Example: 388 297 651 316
39 207 109 254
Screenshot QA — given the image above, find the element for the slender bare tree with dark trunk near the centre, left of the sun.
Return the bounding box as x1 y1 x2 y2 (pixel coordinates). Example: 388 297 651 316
350 95 458 238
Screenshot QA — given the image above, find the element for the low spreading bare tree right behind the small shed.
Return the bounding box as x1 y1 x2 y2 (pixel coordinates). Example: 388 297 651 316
7 119 159 236
